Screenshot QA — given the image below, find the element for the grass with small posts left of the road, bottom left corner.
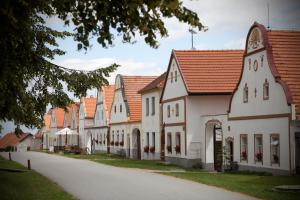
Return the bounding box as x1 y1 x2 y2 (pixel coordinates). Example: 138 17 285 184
0 156 74 200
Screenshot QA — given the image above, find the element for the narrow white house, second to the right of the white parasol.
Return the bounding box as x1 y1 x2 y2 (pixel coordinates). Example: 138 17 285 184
92 85 115 153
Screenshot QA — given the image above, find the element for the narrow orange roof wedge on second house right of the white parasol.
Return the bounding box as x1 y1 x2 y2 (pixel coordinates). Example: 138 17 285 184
101 85 115 124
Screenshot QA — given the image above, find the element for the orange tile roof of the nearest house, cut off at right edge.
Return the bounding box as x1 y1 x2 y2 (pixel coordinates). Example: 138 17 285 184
267 30 300 119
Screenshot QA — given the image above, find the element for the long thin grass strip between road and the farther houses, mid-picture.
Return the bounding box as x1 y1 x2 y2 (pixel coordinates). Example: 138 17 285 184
63 153 183 171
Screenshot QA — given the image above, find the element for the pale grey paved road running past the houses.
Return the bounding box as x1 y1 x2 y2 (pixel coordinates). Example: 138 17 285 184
1 152 252 200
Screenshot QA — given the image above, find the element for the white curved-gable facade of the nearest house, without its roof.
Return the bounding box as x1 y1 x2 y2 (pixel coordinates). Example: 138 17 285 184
224 24 295 174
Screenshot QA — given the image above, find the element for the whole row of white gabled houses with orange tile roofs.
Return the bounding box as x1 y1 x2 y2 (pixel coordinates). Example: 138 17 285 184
43 23 300 174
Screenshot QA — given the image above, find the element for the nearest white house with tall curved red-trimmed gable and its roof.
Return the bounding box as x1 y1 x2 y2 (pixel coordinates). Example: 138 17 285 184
224 23 300 174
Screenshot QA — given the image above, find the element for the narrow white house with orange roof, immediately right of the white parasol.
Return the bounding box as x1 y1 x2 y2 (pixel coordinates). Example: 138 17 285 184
78 97 96 153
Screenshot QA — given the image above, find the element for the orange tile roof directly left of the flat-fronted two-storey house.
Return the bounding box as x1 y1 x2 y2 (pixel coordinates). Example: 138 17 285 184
121 76 157 122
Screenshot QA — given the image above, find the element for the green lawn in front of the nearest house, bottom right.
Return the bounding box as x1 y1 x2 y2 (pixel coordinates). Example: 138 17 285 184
162 172 300 200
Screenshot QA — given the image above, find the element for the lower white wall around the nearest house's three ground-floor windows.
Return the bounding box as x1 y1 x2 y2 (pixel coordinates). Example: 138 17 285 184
224 117 289 170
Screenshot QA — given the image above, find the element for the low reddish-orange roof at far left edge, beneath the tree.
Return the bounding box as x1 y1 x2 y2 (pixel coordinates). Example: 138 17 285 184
0 133 32 149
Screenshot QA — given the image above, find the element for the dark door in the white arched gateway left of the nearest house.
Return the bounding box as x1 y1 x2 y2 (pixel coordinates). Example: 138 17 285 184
214 126 223 172
